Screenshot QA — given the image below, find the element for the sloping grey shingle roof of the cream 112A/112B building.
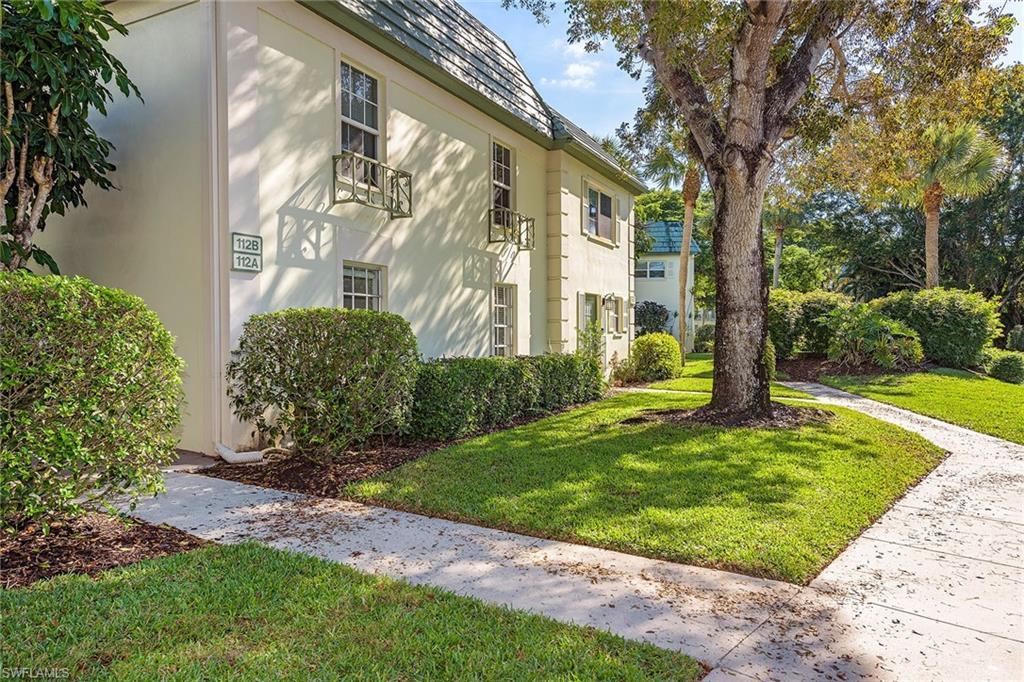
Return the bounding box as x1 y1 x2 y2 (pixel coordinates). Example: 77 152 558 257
300 0 645 191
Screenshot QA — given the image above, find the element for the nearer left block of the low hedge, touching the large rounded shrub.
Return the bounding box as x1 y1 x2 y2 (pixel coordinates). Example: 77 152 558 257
409 357 540 440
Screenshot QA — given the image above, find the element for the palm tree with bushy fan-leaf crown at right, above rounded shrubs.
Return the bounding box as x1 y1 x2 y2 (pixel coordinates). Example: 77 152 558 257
904 123 1005 289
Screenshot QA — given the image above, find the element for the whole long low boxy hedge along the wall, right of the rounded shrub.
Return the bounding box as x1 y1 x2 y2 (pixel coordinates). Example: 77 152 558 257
406 353 604 440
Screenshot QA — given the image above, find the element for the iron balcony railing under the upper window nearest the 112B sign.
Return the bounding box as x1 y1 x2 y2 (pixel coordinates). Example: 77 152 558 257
332 152 413 218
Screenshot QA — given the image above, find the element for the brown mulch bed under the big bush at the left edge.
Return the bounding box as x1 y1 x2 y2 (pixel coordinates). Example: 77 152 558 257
0 513 209 589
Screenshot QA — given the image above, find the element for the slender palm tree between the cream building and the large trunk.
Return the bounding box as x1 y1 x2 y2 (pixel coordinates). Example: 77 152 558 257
644 140 701 358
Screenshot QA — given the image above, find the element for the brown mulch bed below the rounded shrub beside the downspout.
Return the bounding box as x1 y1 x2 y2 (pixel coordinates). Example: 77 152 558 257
196 443 438 498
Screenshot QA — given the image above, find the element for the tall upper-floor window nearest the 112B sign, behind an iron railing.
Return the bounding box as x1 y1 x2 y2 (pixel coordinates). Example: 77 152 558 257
341 61 380 180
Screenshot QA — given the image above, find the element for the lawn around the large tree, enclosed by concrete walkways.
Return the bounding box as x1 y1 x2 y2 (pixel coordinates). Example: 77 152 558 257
346 393 942 583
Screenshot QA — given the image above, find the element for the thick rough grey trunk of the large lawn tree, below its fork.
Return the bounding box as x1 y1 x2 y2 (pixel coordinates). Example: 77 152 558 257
709 167 771 418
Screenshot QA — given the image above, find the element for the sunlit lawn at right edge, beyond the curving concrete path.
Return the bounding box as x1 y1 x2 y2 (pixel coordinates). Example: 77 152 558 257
821 369 1024 444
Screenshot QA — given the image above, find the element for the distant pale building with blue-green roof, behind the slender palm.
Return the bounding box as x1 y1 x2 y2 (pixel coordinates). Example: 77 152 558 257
634 220 700 350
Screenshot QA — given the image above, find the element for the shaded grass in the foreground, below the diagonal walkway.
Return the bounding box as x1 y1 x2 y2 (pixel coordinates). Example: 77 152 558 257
0 544 700 680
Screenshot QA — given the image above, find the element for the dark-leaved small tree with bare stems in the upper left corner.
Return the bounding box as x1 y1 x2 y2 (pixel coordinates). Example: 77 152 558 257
0 0 139 272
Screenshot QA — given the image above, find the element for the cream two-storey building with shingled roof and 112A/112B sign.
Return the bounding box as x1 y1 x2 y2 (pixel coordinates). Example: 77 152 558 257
41 0 645 452
